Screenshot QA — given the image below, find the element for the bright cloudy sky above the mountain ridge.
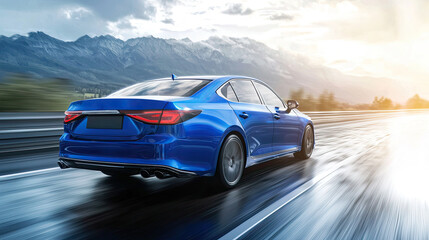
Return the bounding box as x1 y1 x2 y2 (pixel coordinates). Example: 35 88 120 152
0 0 429 92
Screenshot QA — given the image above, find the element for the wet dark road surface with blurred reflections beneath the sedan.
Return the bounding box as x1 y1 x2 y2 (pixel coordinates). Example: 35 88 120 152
0 113 429 239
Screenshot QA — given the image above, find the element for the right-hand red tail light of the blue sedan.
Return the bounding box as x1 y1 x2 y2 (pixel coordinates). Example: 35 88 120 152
121 110 201 125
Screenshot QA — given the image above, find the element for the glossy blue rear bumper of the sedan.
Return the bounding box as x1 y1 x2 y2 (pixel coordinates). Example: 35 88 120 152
59 133 217 176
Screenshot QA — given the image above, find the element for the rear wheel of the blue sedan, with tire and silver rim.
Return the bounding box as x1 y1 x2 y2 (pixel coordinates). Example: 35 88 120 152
214 134 245 189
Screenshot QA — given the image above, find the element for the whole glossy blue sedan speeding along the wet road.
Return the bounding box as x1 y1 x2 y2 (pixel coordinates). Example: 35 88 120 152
58 75 314 188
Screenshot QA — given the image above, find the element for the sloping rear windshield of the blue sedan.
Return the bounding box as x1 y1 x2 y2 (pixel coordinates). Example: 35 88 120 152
107 79 210 97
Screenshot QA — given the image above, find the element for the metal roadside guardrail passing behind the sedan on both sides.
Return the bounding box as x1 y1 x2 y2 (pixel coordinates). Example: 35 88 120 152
0 110 427 157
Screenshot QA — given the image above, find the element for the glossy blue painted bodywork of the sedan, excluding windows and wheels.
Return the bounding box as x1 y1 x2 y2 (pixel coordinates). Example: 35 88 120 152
60 76 312 176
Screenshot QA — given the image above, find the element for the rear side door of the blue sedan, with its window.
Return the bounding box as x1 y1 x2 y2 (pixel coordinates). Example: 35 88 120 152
230 79 274 159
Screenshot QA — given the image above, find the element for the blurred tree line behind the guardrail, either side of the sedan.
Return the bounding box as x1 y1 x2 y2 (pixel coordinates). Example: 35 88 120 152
0 74 429 112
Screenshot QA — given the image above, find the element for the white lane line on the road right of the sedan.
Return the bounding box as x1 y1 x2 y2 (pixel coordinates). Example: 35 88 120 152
219 163 343 240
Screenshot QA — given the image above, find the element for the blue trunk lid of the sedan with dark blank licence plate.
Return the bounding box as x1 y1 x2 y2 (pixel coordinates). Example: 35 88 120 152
65 98 173 141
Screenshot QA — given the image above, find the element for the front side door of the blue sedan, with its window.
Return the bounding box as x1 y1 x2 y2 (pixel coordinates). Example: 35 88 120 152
254 81 301 153
